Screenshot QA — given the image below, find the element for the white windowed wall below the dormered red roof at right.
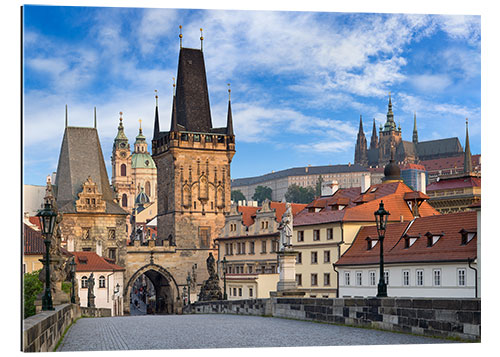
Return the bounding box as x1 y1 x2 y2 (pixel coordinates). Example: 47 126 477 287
338 263 476 298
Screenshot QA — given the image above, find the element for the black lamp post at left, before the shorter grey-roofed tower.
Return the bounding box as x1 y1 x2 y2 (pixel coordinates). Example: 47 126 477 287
36 201 57 310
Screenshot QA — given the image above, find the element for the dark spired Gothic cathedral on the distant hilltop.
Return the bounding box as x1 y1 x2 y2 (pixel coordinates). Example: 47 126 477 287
354 95 464 167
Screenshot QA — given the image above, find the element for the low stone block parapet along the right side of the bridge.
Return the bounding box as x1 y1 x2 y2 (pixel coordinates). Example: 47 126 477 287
184 298 481 341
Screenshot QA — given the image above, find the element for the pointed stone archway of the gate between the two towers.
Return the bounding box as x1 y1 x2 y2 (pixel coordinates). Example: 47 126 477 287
123 263 182 314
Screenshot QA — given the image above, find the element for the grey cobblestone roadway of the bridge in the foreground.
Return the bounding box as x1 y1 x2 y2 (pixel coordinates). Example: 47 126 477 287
58 315 450 351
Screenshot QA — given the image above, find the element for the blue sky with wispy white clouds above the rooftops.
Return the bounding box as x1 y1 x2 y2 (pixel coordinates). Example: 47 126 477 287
23 6 481 185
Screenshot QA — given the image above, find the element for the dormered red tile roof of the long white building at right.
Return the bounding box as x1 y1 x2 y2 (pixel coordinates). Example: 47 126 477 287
335 211 477 266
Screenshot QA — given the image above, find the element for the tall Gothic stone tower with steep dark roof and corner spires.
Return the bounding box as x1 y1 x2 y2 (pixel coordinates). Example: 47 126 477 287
152 47 235 250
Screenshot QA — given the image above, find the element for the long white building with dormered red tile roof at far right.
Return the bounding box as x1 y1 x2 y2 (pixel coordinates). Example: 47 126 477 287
335 210 478 298
